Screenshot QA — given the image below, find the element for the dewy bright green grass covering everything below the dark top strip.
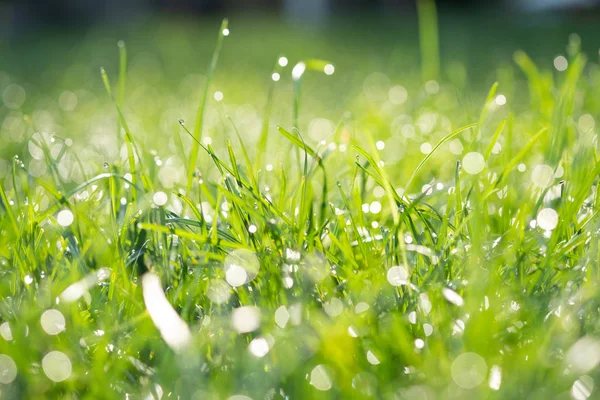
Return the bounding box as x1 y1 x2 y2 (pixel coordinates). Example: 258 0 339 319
0 9 600 400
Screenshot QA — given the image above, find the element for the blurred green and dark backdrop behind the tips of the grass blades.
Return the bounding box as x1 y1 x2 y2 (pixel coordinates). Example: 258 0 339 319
0 0 600 170
